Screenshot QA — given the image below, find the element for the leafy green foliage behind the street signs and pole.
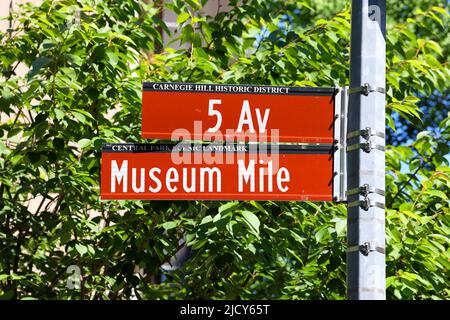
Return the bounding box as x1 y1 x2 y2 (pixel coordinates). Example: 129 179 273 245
0 0 450 299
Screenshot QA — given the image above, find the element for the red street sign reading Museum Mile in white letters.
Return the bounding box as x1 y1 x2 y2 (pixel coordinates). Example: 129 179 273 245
101 143 333 201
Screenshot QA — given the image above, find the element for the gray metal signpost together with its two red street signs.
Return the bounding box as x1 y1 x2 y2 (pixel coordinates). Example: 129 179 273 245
101 0 386 300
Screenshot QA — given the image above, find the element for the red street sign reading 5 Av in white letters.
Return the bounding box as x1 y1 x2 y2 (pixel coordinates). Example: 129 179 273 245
142 82 335 144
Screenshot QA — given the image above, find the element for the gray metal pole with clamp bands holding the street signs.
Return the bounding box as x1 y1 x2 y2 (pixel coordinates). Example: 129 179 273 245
347 0 386 300
